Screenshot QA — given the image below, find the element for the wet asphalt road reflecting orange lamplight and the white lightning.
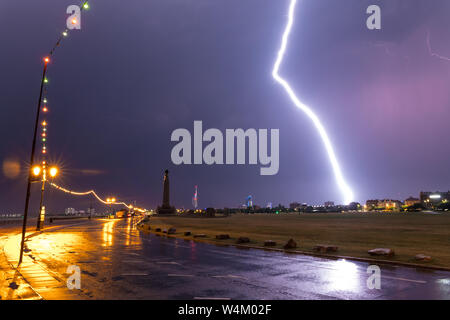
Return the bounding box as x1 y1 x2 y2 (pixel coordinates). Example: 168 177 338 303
7 219 450 299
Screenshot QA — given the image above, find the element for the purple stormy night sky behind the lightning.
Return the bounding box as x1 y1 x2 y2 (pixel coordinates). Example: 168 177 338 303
0 0 450 214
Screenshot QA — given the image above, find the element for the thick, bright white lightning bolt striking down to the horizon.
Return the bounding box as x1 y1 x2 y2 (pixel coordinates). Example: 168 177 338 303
272 0 353 204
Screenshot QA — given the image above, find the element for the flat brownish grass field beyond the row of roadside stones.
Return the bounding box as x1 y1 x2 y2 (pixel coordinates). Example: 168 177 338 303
143 213 450 268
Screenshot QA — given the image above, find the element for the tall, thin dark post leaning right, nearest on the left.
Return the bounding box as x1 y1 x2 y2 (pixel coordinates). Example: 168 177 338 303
19 57 50 265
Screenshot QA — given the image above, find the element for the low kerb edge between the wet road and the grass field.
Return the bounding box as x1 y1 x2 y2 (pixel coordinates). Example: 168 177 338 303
137 222 450 272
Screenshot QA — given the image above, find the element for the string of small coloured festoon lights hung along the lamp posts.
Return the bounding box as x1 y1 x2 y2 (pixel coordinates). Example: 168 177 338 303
40 0 147 213
